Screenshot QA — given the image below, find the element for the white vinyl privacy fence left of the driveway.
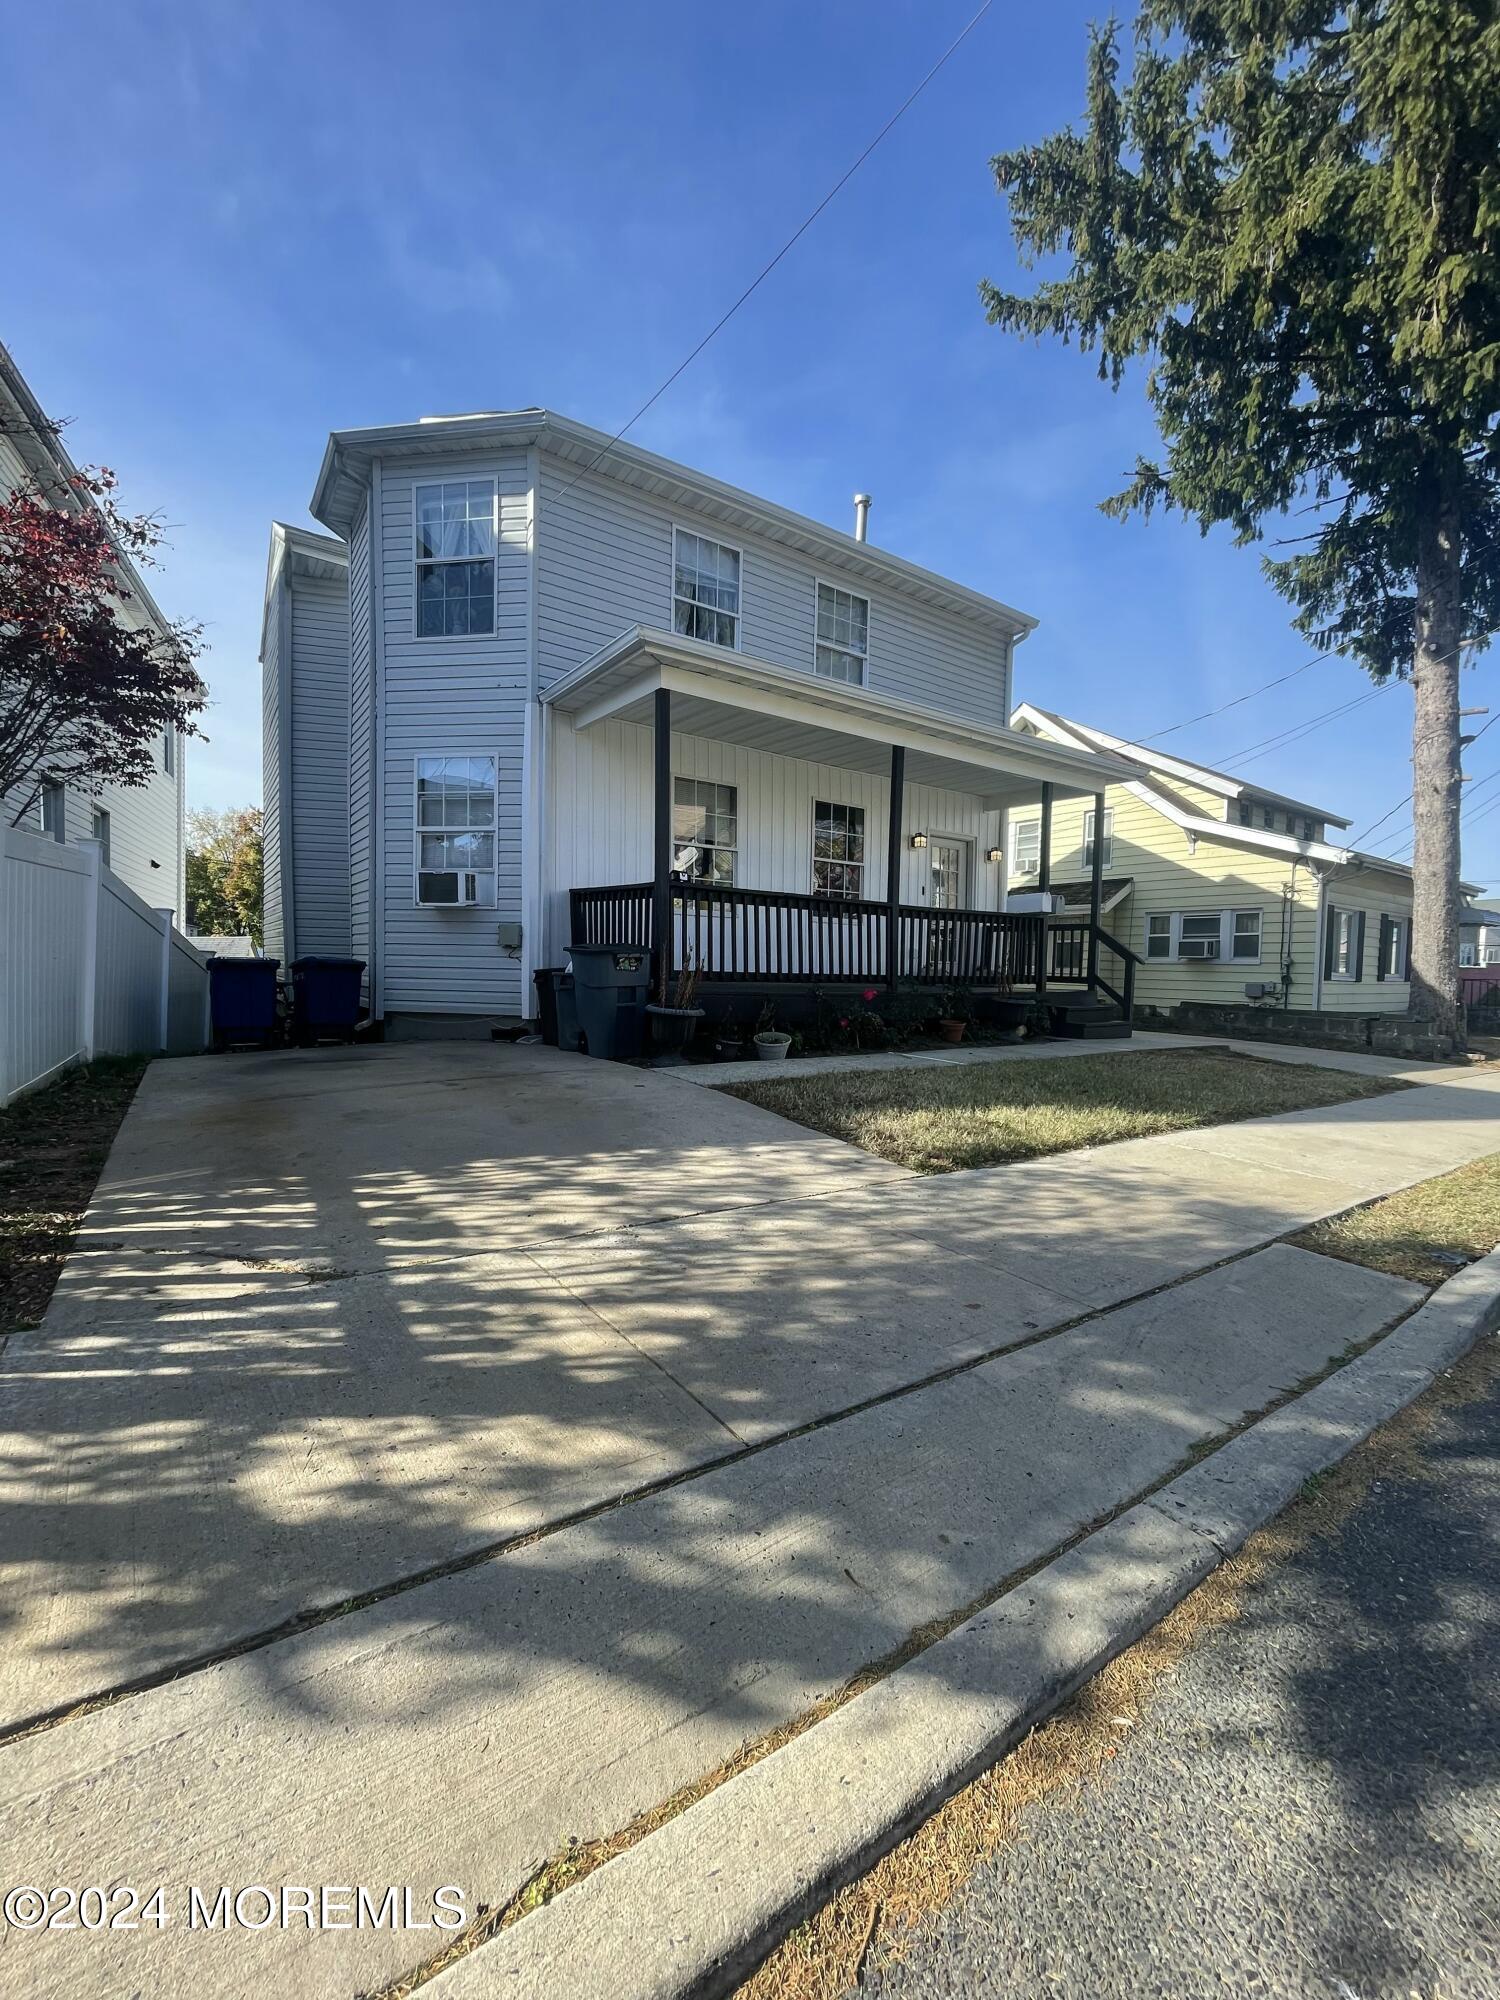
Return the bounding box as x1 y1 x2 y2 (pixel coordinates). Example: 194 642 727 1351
0 826 208 1104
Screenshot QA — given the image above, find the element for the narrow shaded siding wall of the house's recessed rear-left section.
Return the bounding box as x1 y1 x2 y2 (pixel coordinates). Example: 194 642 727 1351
288 576 350 958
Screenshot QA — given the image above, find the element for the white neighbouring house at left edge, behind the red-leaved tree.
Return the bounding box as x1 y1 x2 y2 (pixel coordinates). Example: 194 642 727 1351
0 346 186 924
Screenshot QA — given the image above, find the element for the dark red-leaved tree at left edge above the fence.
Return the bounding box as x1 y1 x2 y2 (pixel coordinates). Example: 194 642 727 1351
0 468 208 824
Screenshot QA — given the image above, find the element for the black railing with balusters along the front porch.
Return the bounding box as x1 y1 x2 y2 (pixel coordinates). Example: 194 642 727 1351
570 882 1136 1020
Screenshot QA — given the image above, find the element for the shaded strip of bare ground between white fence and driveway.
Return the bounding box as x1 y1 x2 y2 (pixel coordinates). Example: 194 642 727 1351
0 1058 146 1344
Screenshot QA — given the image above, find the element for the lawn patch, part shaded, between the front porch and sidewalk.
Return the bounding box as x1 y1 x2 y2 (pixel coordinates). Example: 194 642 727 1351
724 1048 1404 1174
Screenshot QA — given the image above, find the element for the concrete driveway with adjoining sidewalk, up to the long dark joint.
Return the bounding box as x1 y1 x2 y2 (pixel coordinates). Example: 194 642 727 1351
0 1042 1496 1726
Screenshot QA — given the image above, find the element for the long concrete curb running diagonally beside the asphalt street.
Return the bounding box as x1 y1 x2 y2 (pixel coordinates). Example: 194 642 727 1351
430 1250 1500 2000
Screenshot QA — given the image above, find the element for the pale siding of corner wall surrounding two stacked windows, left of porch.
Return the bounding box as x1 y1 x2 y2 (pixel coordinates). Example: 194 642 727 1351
382 450 530 1014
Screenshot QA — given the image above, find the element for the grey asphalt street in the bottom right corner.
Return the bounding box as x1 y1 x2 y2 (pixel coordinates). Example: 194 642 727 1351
862 1352 1500 2000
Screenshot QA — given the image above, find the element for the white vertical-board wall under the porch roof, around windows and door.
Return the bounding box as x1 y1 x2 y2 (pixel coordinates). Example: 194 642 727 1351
540 712 1000 964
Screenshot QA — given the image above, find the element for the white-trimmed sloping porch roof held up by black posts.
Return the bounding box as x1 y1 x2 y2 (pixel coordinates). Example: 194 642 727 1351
542 626 1144 806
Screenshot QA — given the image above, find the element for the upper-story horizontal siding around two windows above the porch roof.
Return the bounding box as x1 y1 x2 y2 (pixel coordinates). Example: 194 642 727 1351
538 456 1010 728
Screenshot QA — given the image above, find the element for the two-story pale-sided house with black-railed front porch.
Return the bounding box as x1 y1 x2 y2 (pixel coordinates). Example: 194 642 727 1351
262 410 1136 1024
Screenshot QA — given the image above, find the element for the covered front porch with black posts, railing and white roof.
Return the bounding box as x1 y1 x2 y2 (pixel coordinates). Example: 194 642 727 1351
544 630 1136 1022
